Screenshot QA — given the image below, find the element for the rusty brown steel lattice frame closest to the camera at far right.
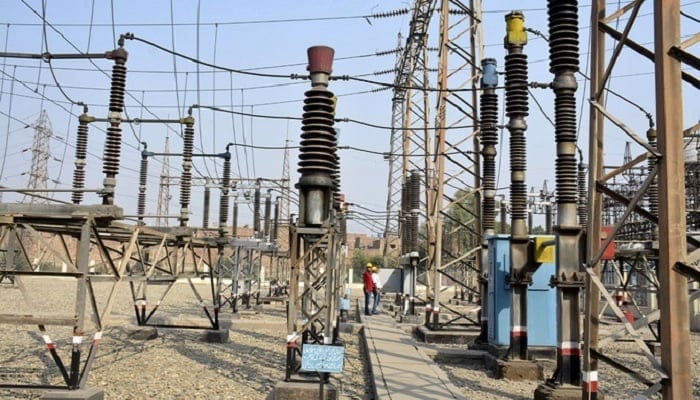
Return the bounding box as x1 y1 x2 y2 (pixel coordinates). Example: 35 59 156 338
583 0 696 399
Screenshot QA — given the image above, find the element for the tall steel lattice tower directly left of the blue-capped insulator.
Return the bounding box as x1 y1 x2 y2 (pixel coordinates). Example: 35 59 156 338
426 0 483 313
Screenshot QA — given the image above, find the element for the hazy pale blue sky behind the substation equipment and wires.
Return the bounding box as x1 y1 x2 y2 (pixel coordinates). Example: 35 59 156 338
0 0 700 234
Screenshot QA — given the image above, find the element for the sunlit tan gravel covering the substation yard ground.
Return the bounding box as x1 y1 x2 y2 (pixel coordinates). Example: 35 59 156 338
0 277 700 400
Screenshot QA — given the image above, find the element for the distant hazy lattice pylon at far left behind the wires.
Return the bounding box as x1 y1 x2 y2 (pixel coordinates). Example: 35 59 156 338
22 110 52 203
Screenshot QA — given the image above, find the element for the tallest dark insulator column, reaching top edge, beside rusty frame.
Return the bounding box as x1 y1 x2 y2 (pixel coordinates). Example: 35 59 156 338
536 0 584 395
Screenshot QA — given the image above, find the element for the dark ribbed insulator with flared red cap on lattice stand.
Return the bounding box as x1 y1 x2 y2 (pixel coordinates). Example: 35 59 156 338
298 46 339 226
